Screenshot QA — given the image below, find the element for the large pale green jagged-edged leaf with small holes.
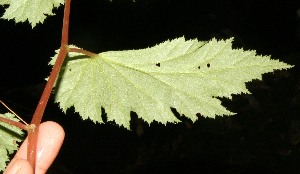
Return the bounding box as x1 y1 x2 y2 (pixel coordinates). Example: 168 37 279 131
51 37 292 128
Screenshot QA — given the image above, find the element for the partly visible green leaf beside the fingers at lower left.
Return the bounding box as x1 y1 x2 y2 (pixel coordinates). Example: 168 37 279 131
0 113 23 172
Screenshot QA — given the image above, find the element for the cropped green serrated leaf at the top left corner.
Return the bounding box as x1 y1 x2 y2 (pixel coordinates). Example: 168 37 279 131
0 0 64 28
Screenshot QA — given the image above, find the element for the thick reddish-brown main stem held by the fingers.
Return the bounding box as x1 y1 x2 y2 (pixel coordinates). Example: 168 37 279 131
27 0 71 171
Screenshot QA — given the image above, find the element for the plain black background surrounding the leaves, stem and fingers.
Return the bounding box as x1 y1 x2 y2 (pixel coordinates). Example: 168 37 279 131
0 0 300 174
